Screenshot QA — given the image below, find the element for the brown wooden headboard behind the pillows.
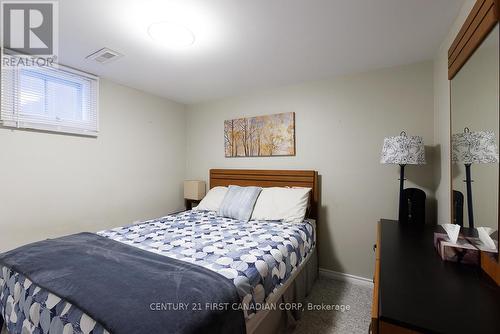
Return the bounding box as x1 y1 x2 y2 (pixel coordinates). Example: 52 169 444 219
210 169 319 219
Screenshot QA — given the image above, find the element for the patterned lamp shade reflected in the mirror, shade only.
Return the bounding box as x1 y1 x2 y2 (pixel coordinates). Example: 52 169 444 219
451 128 498 164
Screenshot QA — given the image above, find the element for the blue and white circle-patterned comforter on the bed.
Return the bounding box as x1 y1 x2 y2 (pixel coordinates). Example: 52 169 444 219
0 210 315 334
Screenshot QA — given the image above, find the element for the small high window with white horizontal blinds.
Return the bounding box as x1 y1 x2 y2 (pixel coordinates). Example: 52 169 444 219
0 58 99 136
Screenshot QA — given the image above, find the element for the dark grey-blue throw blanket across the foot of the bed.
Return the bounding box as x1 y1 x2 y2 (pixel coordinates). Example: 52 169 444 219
0 233 245 334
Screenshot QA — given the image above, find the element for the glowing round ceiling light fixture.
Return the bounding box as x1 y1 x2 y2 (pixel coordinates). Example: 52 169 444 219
148 21 195 49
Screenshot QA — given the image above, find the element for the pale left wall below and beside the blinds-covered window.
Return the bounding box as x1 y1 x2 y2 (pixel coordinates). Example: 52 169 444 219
0 80 185 252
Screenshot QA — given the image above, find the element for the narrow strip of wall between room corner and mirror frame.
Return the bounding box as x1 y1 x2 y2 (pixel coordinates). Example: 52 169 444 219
434 0 476 224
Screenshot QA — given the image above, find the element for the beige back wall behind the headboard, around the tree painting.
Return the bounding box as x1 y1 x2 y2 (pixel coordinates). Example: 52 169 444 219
186 62 434 277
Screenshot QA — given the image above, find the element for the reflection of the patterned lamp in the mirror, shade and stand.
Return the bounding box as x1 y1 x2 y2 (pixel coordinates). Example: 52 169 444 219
451 128 498 228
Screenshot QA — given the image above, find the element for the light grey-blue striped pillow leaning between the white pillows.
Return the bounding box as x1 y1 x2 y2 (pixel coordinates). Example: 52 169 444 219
219 186 262 222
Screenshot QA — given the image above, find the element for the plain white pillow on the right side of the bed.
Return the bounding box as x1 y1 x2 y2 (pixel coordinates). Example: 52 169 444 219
251 187 311 223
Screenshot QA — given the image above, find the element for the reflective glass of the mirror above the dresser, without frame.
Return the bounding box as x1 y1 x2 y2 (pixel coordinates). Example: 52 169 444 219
451 24 500 231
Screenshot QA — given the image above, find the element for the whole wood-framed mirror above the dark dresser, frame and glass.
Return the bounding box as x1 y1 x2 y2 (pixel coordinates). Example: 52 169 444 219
448 0 500 285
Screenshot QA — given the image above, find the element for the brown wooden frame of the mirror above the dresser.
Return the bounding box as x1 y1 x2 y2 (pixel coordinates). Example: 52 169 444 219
448 0 500 285
